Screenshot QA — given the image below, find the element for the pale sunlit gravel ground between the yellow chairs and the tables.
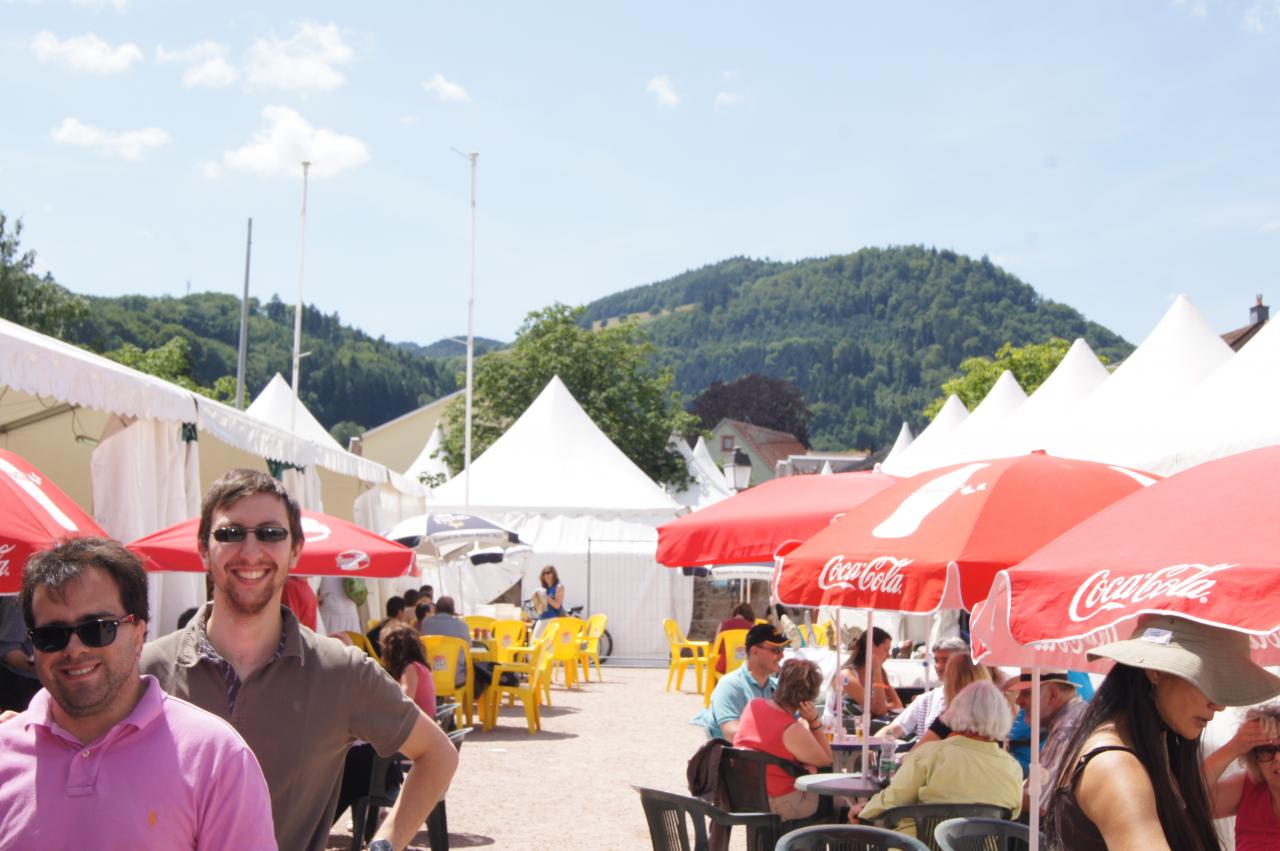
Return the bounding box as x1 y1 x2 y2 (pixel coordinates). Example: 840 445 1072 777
329 665 711 851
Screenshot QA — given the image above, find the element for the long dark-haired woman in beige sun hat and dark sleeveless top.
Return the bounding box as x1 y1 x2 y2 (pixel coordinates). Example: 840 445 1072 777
1046 616 1280 851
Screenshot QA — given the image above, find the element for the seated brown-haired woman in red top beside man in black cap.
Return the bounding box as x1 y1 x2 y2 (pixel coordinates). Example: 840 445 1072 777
733 659 831 820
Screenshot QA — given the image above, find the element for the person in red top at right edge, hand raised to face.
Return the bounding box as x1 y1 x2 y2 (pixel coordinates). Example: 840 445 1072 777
1204 704 1280 851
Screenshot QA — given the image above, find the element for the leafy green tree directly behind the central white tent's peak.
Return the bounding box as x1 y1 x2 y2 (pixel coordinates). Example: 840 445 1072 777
442 303 696 486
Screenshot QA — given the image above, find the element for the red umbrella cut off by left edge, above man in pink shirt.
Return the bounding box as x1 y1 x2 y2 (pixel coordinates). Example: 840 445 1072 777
0 449 106 594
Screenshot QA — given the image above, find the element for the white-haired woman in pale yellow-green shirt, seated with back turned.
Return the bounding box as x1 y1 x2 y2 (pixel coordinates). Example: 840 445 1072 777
850 681 1023 837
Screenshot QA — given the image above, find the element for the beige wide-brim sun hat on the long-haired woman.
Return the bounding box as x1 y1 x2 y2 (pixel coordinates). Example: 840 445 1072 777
1088 614 1280 706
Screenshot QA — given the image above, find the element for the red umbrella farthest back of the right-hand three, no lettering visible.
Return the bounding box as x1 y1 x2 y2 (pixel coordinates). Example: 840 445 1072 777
657 472 899 567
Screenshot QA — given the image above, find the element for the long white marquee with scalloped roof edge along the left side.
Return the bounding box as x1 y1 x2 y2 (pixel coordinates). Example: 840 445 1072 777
0 320 421 633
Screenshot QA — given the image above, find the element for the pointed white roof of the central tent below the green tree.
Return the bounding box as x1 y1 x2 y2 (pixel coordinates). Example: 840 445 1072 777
428 376 681 520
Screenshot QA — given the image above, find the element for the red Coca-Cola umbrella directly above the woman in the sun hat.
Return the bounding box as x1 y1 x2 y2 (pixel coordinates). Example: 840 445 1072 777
972 447 1280 669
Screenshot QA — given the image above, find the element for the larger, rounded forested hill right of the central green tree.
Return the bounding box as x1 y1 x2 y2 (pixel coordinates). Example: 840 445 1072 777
586 246 1133 449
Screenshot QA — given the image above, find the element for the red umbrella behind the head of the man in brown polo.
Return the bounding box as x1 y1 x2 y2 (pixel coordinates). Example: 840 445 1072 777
129 511 416 578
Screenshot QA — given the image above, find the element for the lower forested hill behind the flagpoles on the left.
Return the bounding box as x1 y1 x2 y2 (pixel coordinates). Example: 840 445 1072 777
67 293 460 427
